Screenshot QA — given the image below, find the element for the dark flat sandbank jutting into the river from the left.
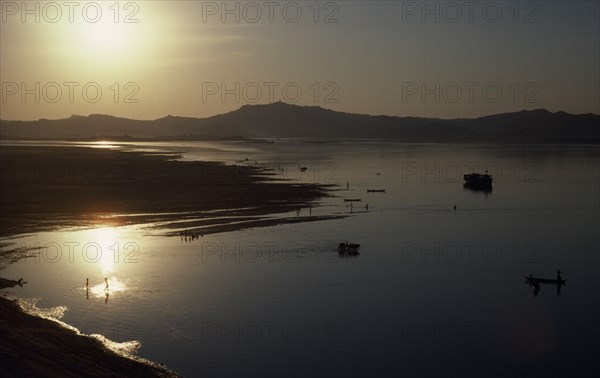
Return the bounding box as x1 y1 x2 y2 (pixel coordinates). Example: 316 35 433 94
0 146 338 236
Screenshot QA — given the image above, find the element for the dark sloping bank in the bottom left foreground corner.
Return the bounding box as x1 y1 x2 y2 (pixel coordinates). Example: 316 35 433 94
0 296 179 377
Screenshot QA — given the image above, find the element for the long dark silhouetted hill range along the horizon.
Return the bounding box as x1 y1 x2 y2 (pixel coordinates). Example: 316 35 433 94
0 102 600 141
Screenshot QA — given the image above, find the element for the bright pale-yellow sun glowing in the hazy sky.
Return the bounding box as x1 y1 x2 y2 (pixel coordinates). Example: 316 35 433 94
49 1 174 73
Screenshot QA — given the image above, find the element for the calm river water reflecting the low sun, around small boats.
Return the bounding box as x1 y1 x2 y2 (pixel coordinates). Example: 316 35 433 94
1 140 600 377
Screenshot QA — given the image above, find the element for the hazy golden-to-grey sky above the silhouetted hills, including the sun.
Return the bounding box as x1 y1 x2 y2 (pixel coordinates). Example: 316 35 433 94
0 0 600 119
